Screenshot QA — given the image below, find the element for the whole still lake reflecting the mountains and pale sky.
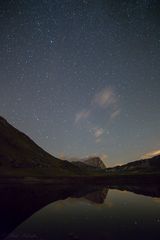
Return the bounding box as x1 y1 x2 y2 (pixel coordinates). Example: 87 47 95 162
0 184 160 240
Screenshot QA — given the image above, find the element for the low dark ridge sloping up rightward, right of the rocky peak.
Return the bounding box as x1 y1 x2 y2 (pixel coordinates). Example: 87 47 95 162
106 155 160 175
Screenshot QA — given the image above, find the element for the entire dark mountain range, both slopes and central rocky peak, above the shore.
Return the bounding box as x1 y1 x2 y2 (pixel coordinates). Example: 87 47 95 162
0 116 160 178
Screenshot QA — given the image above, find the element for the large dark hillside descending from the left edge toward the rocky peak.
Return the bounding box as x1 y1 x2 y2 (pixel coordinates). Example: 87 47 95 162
0 117 104 177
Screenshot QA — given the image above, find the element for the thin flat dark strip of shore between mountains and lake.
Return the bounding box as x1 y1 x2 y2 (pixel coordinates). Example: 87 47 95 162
0 174 160 185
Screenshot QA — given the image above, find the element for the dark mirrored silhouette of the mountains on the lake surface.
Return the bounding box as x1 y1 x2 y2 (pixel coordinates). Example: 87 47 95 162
0 184 160 239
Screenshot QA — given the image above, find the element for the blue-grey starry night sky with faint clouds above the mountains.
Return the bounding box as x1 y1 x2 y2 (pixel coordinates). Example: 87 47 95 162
0 0 160 166
